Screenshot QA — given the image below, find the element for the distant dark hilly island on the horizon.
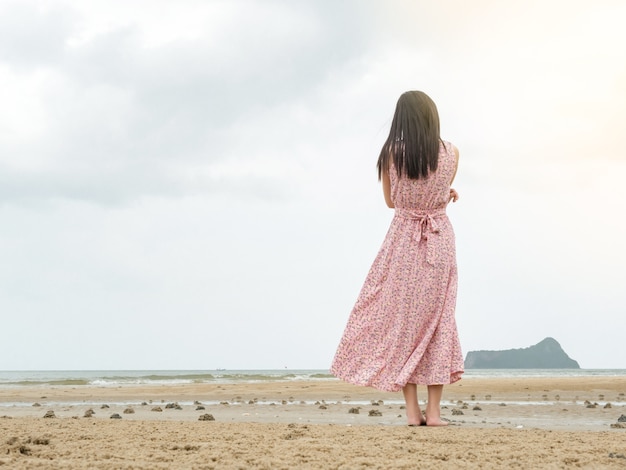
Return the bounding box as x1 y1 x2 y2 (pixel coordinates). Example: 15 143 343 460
465 338 580 369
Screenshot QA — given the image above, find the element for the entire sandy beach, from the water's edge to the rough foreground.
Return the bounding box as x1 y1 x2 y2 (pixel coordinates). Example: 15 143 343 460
0 377 626 469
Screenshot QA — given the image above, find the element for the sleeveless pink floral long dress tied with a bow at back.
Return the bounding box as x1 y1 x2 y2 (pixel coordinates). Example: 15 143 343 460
330 142 463 391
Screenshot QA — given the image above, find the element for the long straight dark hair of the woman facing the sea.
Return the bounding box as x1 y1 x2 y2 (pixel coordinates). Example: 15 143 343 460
377 91 441 179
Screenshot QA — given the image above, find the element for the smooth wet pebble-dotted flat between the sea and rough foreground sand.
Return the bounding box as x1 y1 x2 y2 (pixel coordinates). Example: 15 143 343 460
0 377 626 431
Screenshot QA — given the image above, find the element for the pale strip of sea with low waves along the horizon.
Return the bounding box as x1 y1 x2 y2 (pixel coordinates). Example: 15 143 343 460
0 369 626 388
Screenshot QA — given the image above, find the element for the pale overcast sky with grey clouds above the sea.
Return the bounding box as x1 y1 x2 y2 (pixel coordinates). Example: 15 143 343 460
0 0 626 370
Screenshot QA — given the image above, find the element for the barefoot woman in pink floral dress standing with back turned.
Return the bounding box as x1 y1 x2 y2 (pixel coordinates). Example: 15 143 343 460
331 91 463 426
